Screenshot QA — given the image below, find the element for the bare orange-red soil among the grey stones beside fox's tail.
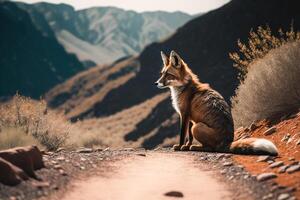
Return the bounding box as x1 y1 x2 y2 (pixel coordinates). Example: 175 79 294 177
234 112 300 198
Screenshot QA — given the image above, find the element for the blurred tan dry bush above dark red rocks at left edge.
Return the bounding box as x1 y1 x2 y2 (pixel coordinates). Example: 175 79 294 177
0 95 69 150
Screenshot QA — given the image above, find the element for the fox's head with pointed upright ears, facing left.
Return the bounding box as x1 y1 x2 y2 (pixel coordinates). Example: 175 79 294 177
155 51 192 89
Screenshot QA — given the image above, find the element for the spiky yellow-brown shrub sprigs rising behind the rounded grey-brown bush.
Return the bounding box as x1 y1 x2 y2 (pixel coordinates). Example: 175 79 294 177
229 25 300 82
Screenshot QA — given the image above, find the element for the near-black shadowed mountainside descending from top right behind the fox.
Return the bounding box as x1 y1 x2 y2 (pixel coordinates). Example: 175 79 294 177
47 0 300 148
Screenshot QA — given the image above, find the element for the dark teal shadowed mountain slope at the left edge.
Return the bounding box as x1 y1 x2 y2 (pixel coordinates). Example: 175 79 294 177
0 2 84 98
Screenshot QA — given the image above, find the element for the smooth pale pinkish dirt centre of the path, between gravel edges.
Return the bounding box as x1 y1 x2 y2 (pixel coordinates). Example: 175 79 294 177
63 153 232 200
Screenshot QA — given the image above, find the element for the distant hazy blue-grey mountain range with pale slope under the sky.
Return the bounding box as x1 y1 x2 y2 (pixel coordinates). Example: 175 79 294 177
19 3 192 64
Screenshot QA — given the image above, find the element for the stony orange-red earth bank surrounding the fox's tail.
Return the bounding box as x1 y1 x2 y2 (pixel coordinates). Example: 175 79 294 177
233 113 300 198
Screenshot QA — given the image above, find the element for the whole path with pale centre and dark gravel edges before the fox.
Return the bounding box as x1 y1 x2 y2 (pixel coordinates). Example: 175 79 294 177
0 148 286 200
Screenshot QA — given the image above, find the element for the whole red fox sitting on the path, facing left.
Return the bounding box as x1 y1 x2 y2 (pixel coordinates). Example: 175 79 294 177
155 51 278 155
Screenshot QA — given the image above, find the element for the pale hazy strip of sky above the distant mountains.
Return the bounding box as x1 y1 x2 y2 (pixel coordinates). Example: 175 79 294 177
11 0 229 14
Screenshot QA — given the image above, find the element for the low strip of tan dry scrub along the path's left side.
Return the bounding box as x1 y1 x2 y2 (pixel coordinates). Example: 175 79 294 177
0 94 109 151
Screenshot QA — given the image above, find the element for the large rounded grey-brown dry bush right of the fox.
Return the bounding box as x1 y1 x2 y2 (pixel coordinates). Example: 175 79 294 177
232 41 300 128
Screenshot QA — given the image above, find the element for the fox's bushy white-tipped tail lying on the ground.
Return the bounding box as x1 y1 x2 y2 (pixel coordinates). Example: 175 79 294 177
229 138 278 156
